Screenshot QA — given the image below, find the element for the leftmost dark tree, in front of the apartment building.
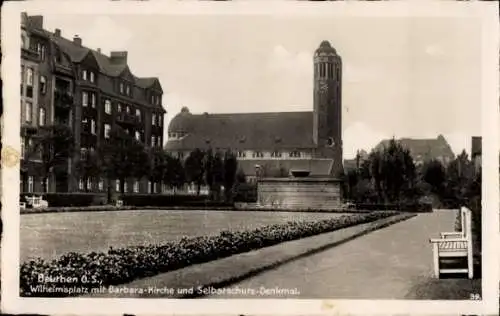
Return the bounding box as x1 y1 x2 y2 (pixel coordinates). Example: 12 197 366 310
27 124 75 191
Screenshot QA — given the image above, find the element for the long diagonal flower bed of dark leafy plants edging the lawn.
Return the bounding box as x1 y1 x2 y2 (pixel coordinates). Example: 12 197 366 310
20 211 398 297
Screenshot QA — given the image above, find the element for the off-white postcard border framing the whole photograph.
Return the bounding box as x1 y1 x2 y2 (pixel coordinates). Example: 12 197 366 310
1 0 500 315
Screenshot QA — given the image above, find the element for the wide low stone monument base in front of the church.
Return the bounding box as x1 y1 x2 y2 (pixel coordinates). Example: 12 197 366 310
257 177 342 210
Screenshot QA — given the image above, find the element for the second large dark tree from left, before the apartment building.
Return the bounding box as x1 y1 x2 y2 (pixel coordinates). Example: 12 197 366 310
102 128 150 193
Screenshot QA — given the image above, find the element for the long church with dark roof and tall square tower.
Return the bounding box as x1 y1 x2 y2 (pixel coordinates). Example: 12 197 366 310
166 41 343 178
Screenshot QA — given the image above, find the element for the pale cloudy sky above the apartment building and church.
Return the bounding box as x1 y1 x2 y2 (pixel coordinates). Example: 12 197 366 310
44 14 481 158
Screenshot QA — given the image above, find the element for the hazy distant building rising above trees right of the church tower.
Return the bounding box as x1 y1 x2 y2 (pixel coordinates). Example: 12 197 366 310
375 135 455 166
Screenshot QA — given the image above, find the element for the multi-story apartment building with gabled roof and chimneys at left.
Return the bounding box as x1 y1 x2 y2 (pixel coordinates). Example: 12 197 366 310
21 14 166 192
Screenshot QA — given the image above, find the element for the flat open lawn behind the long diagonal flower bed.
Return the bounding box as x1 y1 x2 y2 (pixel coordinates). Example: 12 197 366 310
20 210 348 262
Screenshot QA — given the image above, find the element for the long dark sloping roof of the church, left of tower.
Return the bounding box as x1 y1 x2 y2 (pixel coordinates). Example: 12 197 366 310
166 110 316 150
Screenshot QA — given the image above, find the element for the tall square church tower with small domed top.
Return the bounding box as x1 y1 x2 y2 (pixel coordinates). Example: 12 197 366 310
313 41 343 176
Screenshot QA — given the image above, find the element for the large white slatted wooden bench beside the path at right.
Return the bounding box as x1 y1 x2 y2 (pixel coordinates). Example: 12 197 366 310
430 207 474 279
